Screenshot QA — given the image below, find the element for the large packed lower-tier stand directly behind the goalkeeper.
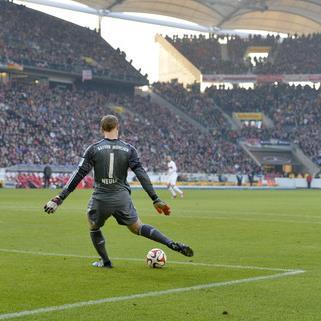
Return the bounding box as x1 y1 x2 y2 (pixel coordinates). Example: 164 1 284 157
0 82 254 173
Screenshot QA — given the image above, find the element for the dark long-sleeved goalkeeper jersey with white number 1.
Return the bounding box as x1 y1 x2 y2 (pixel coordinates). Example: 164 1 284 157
59 138 157 200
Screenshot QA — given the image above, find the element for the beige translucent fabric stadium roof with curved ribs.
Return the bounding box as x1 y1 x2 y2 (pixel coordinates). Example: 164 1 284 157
72 0 321 33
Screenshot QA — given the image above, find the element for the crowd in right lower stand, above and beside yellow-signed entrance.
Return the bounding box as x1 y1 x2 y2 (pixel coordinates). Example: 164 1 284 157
206 84 321 165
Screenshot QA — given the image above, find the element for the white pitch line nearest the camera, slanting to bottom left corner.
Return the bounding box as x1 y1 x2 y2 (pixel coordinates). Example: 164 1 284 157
0 270 304 320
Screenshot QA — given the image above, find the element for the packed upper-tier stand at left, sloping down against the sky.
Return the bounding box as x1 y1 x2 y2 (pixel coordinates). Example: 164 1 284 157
0 1 144 80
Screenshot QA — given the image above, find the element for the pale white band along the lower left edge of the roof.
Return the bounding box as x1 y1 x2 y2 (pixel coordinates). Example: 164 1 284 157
20 0 220 33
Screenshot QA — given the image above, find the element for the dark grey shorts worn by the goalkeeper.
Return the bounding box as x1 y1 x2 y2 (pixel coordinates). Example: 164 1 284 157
87 193 138 227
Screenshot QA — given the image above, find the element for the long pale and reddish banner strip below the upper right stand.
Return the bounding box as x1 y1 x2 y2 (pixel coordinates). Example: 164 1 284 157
202 74 321 83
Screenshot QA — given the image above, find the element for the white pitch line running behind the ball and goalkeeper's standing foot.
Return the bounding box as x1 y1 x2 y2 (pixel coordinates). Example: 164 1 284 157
0 248 304 272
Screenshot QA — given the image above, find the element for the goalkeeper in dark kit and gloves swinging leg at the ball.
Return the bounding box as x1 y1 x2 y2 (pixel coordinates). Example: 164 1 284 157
44 115 193 268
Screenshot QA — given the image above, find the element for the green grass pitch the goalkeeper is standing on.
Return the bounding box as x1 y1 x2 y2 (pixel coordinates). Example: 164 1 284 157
0 190 321 321
